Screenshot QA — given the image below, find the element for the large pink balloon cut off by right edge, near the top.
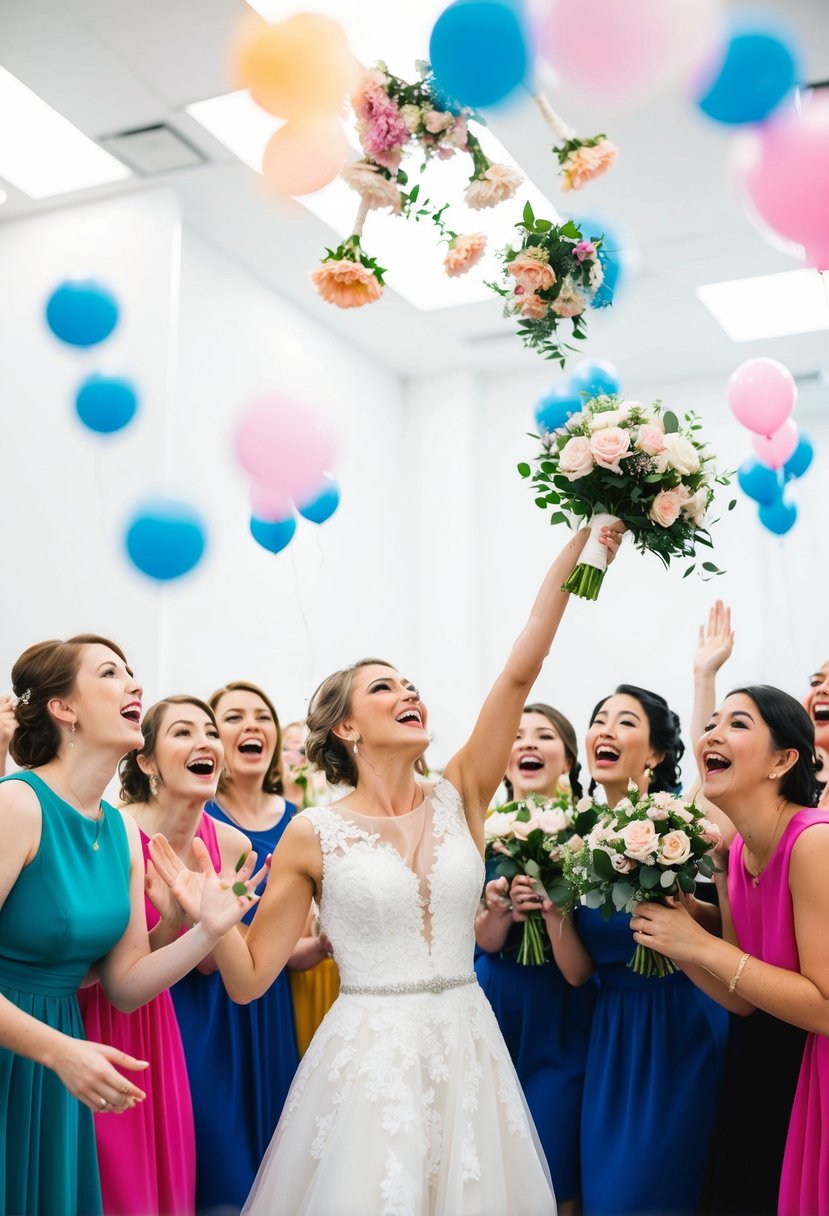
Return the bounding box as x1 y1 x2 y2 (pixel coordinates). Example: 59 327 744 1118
738 94 829 270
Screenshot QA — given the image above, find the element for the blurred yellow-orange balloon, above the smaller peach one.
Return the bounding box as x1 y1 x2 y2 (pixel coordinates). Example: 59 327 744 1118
231 12 360 118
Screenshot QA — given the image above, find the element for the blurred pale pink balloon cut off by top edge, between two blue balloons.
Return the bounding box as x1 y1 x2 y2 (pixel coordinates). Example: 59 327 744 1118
538 0 721 102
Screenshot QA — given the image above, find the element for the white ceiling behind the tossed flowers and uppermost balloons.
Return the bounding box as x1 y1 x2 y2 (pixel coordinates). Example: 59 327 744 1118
0 0 829 381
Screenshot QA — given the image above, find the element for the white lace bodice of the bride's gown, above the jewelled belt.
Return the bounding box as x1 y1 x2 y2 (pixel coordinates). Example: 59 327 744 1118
296 779 484 985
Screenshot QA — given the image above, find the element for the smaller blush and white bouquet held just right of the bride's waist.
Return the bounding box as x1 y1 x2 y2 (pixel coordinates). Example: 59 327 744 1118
484 793 594 966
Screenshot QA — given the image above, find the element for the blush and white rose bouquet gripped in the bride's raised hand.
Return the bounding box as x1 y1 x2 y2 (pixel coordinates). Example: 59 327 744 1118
518 394 734 599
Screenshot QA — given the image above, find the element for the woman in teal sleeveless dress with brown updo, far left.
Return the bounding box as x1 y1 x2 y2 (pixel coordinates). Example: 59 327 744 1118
0 634 261 1216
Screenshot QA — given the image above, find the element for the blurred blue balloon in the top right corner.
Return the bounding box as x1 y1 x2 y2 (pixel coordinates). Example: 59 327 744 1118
697 18 800 126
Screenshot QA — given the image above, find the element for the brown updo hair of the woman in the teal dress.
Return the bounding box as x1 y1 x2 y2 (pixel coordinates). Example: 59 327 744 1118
9 634 126 769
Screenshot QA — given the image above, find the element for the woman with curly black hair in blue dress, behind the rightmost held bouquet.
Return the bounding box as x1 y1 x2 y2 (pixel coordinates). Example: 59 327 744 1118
551 685 727 1216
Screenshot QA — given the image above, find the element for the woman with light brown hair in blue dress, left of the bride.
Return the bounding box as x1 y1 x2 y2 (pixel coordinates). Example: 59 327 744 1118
173 681 327 1212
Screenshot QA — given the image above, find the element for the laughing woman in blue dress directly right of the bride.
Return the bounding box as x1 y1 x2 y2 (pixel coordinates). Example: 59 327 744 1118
475 702 596 1216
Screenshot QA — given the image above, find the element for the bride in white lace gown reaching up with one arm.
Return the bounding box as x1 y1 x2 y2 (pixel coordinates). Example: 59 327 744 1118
151 528 621 1216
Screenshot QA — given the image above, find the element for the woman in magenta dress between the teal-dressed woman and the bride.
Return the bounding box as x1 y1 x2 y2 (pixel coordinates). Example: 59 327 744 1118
78 697 249 1216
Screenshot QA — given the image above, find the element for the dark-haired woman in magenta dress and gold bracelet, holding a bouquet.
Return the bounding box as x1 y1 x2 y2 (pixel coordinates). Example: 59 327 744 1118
632 685 829 1216
